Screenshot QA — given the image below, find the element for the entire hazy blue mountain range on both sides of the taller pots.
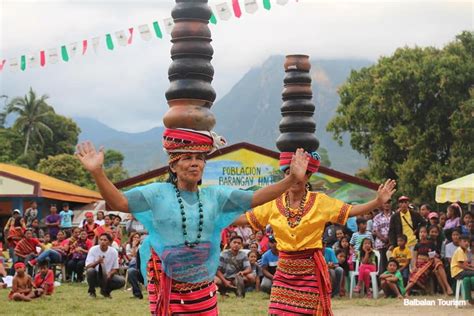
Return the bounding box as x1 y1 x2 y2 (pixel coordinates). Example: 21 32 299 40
74 56 371 176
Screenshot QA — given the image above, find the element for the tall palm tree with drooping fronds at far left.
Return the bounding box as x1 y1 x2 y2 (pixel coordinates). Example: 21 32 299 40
6 88 53 155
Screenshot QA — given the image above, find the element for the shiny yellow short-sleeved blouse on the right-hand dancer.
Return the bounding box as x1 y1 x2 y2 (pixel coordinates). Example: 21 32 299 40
246 192 352 251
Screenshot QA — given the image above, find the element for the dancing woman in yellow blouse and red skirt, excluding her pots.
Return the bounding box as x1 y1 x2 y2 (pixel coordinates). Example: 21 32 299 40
234 152 395 316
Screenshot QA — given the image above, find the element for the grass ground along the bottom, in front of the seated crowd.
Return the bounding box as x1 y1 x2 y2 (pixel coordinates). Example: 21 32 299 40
0 283 474 316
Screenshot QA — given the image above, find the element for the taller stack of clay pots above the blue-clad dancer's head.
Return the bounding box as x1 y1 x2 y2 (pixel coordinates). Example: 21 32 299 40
163 0 216 131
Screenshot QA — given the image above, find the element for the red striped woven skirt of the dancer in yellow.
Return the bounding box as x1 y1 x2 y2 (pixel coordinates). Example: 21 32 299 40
269 249 333 316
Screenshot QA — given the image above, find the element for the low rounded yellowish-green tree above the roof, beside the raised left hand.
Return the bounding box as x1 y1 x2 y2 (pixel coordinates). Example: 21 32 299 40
37 154 95 189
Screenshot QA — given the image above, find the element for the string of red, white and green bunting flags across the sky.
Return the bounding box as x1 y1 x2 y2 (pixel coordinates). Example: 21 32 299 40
0 0 298 72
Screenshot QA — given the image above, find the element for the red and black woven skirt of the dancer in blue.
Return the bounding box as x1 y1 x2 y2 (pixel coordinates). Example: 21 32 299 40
147 250 218 316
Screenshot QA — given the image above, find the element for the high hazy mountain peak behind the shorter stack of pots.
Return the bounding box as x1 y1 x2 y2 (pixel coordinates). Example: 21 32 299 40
212 56 371 174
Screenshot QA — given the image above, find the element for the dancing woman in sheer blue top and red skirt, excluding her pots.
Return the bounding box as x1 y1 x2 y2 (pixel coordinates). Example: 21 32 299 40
76 129 309 315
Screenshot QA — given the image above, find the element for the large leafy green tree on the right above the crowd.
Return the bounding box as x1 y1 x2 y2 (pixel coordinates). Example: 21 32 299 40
327 31 474 202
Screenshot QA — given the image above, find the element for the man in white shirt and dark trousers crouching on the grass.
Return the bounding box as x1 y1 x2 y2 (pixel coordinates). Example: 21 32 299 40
86 233 125 298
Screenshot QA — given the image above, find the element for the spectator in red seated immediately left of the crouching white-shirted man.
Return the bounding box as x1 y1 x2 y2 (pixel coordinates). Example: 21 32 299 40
67 227 93 282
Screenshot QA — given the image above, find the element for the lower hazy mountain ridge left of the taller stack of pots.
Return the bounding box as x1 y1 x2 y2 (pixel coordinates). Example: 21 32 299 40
73 117 166 176
